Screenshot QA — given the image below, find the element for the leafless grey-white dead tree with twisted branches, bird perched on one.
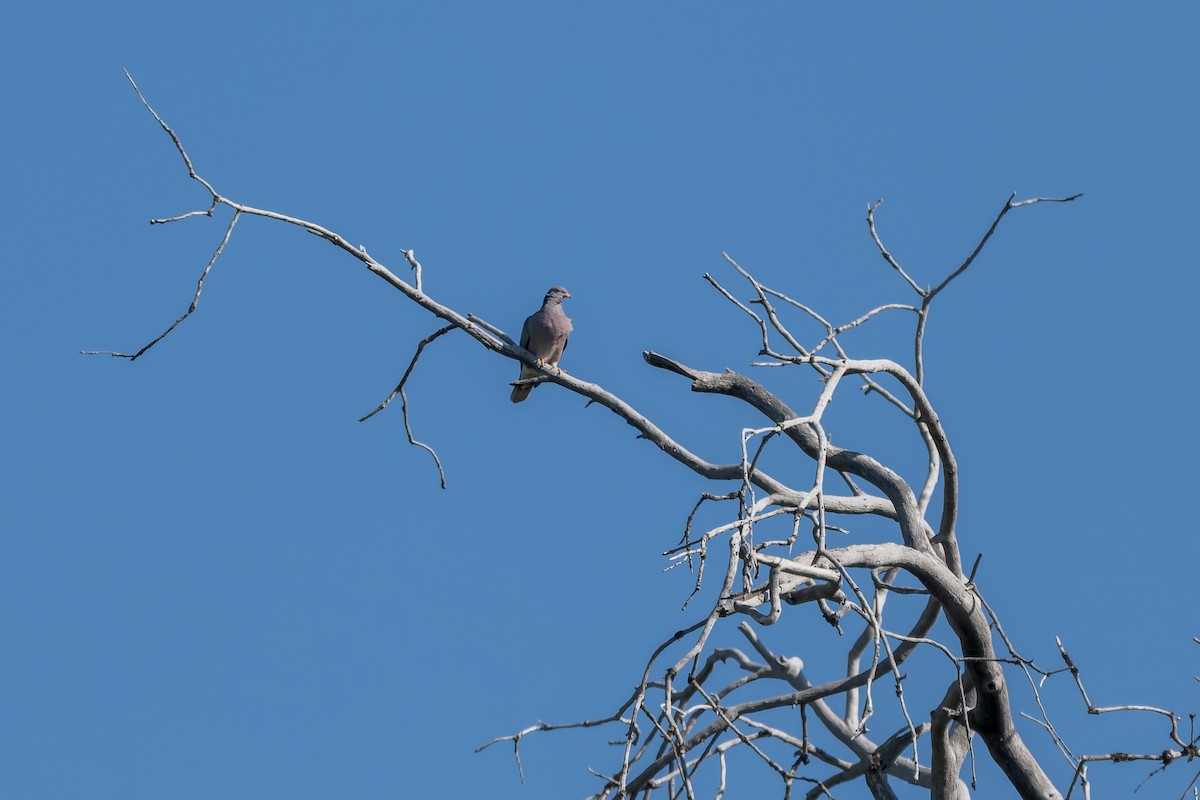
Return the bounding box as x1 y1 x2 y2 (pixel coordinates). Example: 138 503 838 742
90 78 1200 799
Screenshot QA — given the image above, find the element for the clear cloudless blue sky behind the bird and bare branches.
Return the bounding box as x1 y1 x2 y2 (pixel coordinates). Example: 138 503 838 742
0 2 1200 800
